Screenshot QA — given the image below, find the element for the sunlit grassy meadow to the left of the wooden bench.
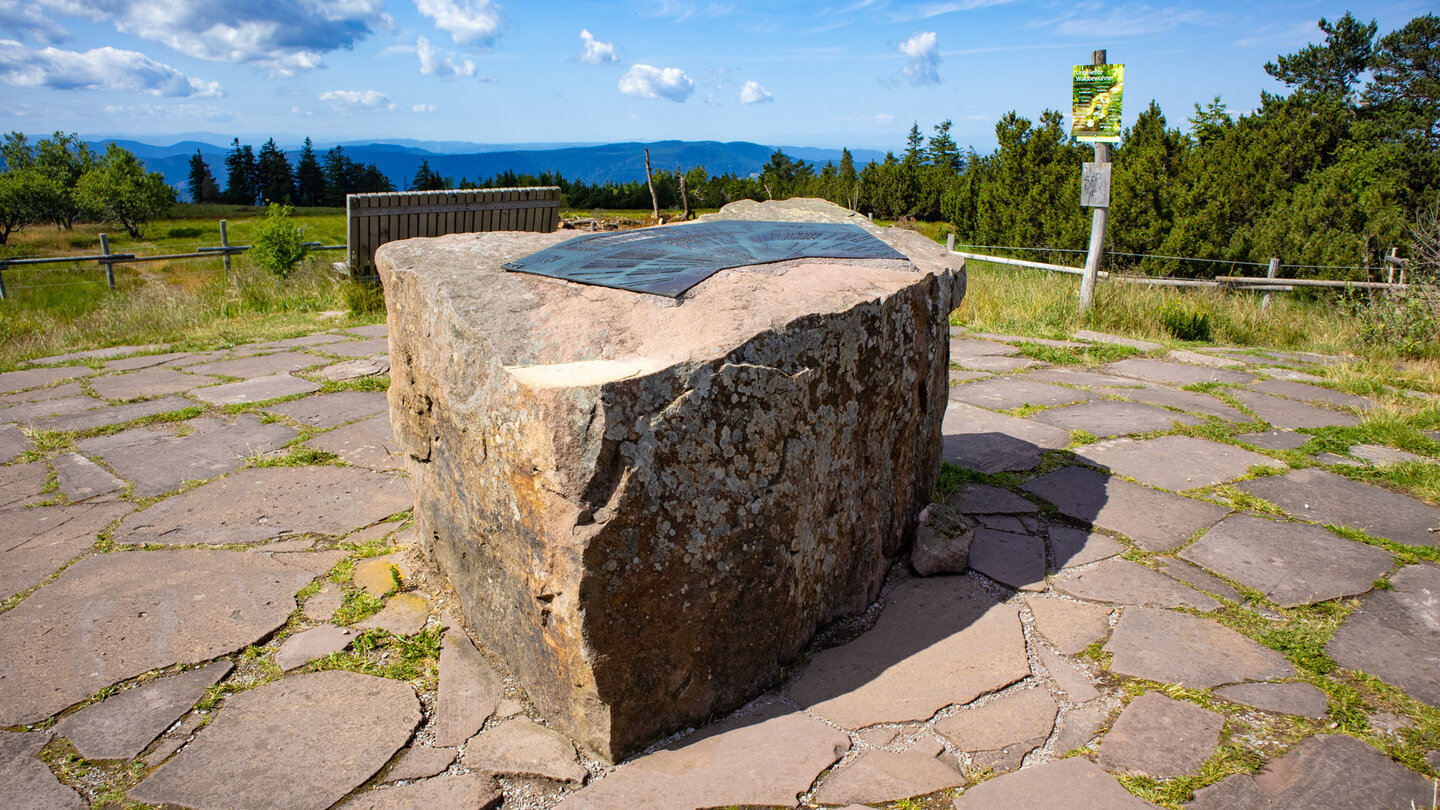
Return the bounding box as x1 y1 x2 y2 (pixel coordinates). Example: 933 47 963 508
0 205 371 370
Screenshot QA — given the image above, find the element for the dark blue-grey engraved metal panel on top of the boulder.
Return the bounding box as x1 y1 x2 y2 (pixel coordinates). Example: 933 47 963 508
504 221 906 298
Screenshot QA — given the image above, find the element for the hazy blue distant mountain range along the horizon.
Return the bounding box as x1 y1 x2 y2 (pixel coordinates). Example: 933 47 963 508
88 138 884 196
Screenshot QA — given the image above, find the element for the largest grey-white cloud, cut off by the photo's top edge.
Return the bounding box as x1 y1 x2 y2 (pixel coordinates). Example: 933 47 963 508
37 0 392 78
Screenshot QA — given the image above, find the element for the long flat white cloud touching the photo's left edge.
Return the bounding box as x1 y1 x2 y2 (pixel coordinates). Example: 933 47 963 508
0 39 225 98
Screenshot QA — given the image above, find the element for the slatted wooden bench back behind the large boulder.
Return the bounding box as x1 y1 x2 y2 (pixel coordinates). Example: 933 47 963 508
343 186 560 278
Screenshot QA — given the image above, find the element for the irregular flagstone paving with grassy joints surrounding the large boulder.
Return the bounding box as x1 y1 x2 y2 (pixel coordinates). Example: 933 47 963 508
0 318 1440 810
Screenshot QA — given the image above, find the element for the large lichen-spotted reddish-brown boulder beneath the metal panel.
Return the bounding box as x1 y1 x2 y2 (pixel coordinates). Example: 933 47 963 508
376 200 965 758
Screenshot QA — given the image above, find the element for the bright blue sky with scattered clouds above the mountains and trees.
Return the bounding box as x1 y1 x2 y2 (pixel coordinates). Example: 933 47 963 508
0 0 1434 150
